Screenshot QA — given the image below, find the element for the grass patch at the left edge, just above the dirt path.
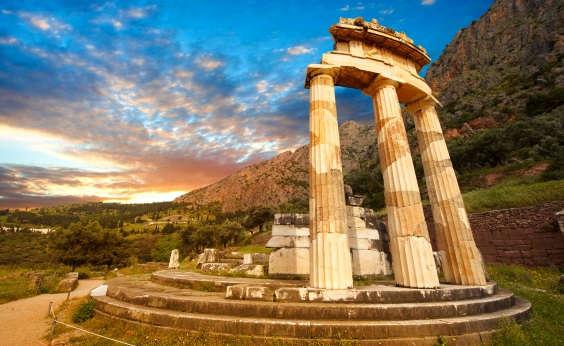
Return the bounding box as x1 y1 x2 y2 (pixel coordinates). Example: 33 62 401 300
0 266 68 304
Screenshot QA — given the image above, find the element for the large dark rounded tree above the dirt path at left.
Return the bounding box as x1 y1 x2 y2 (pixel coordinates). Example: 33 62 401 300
51 221 128 270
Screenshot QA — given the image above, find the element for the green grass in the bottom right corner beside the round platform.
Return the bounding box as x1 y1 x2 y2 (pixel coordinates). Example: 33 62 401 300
488 264 564 345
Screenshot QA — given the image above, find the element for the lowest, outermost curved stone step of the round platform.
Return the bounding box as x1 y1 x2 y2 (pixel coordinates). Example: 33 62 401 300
94 296 531 340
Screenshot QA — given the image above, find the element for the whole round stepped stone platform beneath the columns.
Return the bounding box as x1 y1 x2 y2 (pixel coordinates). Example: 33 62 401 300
94 271 530 345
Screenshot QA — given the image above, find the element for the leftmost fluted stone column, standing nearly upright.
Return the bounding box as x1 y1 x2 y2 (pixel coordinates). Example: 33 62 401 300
309 74 353 289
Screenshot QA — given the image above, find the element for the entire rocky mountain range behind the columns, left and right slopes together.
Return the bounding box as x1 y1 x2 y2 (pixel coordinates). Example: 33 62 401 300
176 0 564 211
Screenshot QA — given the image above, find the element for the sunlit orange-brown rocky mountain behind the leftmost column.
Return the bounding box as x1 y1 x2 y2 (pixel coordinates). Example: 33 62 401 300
176 121 376 211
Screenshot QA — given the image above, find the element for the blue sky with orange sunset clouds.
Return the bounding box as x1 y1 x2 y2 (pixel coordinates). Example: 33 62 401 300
0 0 491 208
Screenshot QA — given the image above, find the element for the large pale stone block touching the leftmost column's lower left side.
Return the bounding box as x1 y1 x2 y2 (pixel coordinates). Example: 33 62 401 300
268 248 309 275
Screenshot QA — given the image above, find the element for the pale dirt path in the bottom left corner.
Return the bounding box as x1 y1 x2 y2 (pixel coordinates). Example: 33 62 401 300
0 280 103 346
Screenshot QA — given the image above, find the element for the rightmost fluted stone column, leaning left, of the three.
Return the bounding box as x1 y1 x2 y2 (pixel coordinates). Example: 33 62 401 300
408 98 486 285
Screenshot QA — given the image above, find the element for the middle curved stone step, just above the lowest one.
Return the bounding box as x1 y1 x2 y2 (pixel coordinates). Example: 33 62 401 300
107 279 514 321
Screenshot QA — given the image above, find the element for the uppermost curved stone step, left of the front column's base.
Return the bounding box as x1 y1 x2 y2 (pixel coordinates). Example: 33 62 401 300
151 270 304 292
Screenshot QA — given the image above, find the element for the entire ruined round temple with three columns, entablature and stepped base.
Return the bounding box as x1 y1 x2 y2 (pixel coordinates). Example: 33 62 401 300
93 18 531 346
